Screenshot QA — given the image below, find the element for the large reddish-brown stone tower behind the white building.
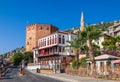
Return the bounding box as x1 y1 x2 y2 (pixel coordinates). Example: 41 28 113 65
26 24 58 51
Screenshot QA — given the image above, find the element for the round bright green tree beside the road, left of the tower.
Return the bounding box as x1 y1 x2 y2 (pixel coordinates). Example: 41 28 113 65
12 53 23 66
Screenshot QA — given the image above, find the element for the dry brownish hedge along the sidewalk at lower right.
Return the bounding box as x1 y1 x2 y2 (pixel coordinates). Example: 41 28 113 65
65 66 120 80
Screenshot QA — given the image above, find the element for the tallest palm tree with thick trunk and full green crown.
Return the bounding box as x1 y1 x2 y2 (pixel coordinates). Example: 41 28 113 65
81 26 101 72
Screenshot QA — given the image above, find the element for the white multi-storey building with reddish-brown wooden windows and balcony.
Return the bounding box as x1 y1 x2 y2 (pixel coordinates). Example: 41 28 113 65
33 31 77 70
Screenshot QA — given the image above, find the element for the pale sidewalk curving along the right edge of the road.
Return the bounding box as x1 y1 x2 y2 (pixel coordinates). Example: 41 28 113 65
27 69 119 82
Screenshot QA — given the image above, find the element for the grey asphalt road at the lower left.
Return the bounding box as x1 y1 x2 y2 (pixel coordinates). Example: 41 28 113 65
0 66 63 82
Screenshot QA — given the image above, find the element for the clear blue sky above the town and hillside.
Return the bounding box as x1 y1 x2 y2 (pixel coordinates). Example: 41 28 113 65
0 0 120 54
